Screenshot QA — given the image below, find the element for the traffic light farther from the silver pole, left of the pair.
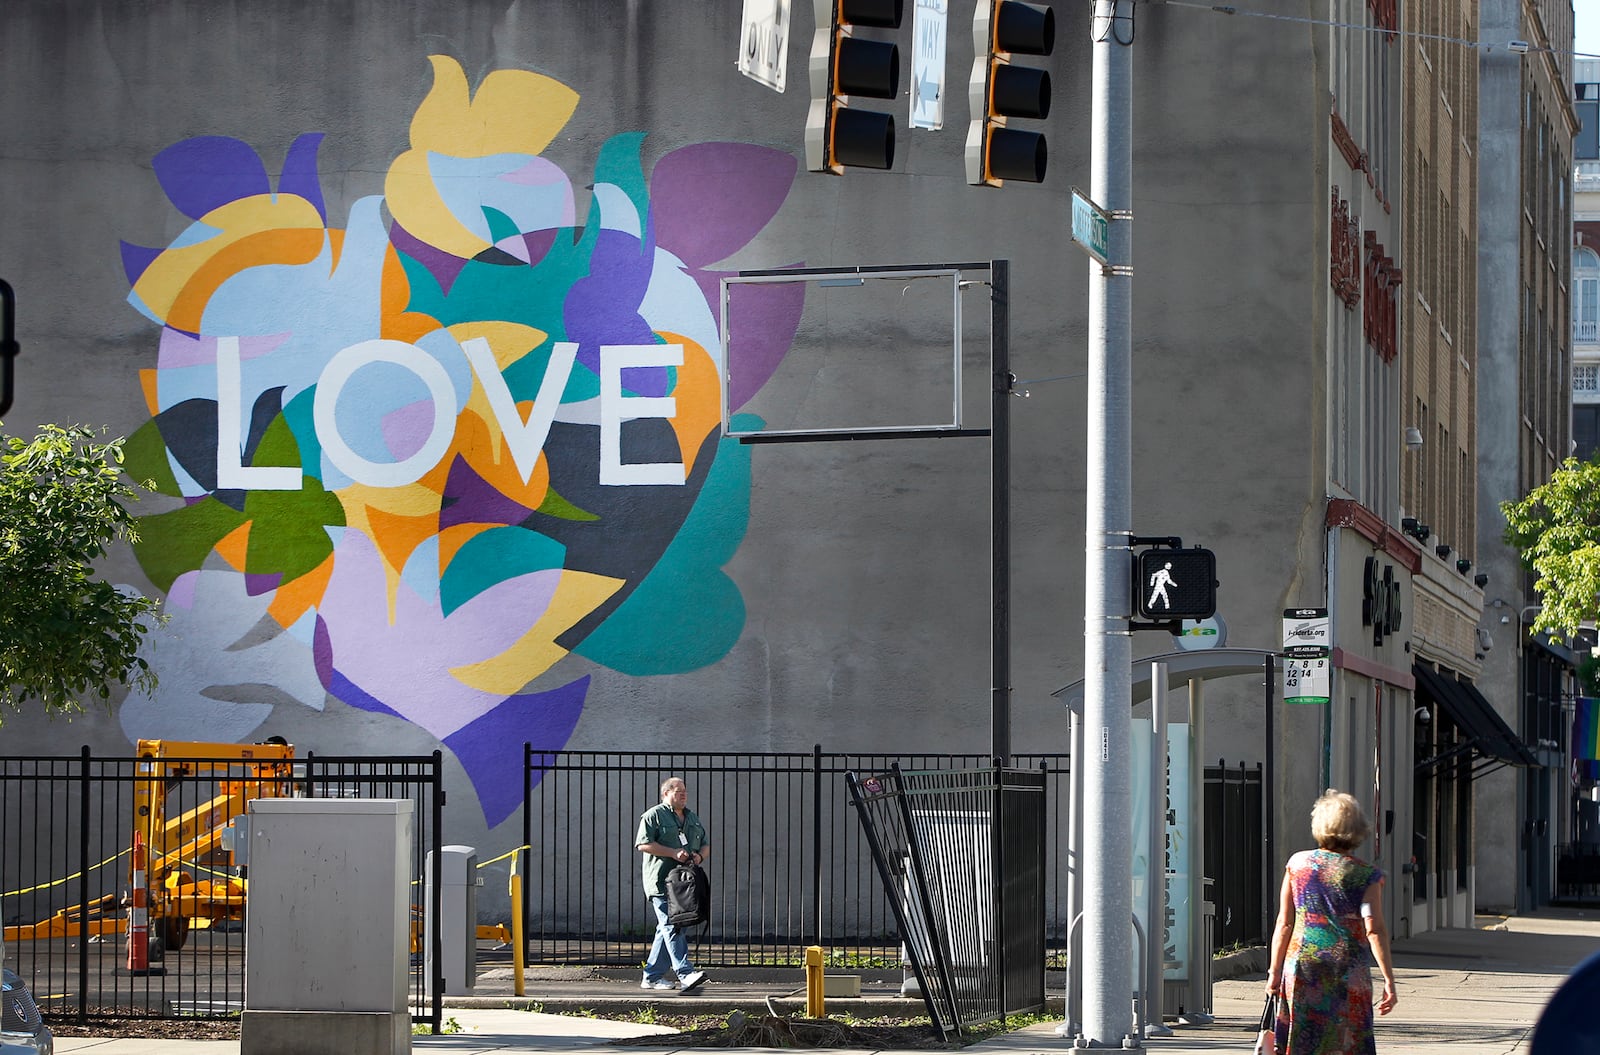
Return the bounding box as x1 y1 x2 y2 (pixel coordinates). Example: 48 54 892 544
805 0 904 173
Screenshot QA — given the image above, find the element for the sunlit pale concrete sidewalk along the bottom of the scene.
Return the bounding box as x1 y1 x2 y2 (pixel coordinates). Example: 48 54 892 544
43 909 1600 1055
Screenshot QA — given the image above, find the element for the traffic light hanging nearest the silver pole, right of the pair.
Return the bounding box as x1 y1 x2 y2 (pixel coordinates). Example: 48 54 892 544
966 0 1056 187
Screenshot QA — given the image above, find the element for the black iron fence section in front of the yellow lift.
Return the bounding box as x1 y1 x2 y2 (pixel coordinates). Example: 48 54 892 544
0 744 443 1031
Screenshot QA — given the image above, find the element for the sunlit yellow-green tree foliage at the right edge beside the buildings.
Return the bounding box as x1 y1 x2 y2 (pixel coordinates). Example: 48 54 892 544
1501 458 1600 634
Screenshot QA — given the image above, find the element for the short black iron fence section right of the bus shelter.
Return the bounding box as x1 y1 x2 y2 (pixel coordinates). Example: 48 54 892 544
1205 760 1275 949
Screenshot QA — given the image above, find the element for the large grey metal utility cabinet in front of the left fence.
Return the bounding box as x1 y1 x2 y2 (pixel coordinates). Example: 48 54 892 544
240 799 413 1055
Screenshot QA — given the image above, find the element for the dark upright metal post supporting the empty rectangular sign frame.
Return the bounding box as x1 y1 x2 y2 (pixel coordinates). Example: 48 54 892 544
989 259 1011 767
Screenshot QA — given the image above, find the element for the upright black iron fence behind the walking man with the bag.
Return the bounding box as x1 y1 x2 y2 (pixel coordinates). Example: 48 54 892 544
523 746 1069 967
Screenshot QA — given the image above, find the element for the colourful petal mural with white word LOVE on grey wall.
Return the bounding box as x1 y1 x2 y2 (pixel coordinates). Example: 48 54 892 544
120 56 803 826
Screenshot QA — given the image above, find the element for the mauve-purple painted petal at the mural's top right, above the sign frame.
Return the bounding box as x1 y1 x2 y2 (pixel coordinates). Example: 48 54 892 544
650 142 798 267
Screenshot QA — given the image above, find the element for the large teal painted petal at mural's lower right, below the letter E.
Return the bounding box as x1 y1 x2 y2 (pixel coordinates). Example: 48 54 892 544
574 415 758 676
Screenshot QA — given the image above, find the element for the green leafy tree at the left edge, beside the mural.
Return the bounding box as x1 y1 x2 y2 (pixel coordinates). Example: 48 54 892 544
0 424 160 720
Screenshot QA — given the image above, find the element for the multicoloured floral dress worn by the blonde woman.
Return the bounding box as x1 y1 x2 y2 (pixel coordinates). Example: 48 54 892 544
1277 850 1384 1055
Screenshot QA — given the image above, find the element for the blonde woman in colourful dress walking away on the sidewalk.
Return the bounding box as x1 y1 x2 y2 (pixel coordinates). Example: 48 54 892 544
1267 788 1398 1055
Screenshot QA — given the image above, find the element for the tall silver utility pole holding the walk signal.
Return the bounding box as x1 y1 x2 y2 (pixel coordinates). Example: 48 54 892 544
1072 0 1141 1047
